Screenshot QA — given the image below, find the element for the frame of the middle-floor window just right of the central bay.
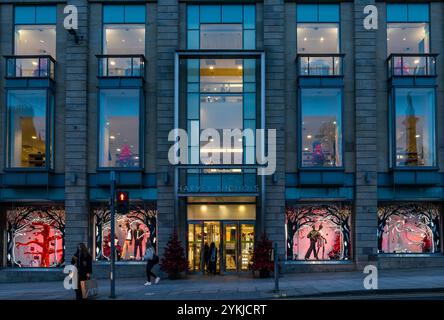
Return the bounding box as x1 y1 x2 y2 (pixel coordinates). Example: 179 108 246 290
296 86 345 171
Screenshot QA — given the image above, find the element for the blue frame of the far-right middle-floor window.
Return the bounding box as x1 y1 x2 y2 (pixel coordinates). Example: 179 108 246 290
388 86 439 171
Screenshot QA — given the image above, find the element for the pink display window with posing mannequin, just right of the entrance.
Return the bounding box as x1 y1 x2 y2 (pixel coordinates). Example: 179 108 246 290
285 204 351 260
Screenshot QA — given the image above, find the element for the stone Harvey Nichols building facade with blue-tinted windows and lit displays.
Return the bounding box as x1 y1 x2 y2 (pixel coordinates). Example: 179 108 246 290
0 0 444 280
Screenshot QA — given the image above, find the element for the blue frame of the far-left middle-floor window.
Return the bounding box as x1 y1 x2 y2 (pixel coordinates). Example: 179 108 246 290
4 87 56 172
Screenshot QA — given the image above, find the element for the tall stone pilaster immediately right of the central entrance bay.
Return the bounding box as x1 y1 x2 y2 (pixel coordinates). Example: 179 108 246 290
260 0 285 255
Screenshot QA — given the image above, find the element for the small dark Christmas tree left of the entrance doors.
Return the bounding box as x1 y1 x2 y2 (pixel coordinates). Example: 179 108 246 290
160 231 188 279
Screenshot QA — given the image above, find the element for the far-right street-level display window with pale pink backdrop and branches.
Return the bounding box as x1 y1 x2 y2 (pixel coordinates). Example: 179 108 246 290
378 203 441 253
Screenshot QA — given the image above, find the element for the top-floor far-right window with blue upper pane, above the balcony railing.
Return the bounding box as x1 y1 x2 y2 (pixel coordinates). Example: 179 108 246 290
387 4 430 54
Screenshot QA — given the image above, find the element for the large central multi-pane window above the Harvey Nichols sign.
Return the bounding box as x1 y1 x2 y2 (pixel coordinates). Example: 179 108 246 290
186 59 258 165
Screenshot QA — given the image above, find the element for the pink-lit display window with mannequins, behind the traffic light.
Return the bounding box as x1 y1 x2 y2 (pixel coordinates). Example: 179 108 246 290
94 205 157 261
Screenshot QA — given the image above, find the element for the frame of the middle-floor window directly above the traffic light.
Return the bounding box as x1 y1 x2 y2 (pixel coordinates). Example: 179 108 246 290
96 86 146 172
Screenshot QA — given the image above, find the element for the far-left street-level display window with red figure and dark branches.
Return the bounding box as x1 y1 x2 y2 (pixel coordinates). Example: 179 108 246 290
6 207 65 267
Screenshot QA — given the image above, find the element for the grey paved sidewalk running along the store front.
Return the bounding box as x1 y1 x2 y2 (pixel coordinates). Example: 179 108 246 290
0 268 444 300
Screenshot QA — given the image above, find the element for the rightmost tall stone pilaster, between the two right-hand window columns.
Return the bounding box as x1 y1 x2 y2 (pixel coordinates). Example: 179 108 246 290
354 0 378 268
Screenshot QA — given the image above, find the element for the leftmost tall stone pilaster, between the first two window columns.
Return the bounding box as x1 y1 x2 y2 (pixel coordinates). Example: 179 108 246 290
63 0 91 259
